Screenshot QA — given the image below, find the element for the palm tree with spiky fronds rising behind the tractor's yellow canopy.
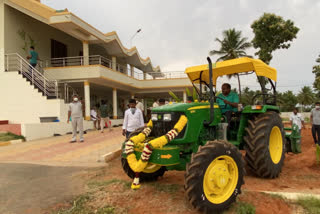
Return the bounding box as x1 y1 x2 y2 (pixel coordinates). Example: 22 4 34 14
209 28 252 61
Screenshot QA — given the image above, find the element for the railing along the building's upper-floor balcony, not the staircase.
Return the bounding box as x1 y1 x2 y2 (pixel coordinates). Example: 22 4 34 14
44 55 187 80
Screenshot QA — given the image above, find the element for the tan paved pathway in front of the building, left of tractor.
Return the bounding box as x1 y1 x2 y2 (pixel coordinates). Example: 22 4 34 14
0 127 125 167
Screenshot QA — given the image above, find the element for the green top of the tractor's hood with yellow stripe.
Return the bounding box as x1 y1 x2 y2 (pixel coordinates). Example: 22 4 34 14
152 102 218 113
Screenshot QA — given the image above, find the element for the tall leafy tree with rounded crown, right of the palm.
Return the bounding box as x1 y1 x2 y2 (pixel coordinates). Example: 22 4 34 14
251 13 299 64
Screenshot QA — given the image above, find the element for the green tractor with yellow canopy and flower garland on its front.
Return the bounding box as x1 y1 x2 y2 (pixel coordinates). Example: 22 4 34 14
121 57 285 213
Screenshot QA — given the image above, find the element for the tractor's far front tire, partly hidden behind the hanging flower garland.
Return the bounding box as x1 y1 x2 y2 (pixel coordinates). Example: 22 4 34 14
121 127 166 182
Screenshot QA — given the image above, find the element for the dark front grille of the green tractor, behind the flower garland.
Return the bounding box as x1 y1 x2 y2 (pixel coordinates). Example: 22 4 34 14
150 112 186 139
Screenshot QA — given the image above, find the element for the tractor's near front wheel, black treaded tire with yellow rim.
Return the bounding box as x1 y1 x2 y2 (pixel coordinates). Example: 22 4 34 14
184 140 245 213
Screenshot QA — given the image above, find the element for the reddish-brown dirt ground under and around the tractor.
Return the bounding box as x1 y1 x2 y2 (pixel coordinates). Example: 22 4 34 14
48 128 320 214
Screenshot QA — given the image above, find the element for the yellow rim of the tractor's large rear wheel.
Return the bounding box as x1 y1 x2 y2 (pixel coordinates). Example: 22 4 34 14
269 126 283 164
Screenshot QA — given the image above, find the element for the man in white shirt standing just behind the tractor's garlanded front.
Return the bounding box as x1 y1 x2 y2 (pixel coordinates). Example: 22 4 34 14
122 99 144 138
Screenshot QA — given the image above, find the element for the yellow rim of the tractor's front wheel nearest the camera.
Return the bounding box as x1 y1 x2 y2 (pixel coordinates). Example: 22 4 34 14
203 155 239 204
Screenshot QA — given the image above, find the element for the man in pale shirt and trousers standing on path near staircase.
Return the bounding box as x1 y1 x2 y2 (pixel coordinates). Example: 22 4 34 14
67 95 84 143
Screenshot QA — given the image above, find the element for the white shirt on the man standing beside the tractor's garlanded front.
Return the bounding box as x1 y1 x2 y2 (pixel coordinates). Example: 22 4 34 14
122 108 144 132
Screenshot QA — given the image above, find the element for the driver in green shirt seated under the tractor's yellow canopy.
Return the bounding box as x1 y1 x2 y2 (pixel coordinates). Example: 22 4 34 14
217 83 239 123
